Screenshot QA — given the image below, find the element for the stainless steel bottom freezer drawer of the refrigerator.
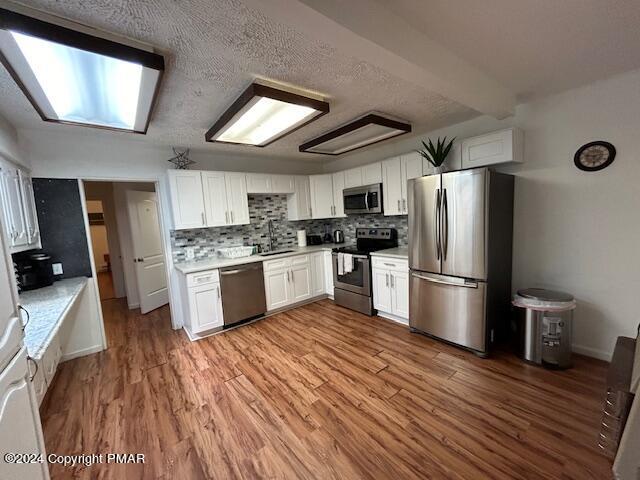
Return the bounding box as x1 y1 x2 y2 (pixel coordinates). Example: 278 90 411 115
409 270 487 352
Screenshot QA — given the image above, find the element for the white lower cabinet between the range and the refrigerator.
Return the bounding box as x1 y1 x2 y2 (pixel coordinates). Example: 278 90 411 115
371 256 409 323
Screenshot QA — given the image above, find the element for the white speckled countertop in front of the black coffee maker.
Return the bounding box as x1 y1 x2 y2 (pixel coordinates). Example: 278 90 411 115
20 277 89 360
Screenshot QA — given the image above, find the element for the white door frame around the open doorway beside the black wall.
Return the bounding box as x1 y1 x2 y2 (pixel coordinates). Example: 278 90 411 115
78 175 182 349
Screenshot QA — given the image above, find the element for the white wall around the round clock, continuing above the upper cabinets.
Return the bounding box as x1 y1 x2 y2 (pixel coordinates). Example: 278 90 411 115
325 67 640 359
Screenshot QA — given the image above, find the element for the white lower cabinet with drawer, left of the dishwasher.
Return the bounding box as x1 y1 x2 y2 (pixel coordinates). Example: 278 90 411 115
182 270 224 335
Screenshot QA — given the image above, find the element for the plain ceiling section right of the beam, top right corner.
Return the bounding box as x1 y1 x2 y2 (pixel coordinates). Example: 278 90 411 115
388 0 640 100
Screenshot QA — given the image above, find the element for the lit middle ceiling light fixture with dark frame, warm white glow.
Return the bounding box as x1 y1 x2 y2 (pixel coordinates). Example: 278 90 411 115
205 83 329 147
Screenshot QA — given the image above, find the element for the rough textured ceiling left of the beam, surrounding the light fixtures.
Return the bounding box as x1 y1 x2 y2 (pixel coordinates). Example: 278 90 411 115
0 0 477 161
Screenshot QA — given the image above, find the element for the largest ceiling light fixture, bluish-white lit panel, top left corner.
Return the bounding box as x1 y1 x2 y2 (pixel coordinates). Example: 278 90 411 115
0 8 164 133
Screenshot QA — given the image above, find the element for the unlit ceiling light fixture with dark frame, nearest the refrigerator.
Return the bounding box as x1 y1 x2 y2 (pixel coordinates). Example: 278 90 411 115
299 113 411 155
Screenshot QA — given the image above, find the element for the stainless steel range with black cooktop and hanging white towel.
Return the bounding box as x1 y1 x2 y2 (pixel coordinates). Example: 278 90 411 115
333 228 398 315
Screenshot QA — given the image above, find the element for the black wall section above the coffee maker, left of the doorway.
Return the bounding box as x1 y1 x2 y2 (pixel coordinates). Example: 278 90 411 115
24 178 91 278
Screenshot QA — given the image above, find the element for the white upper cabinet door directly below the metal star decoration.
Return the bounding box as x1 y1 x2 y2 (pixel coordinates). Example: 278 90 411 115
168 170 206 230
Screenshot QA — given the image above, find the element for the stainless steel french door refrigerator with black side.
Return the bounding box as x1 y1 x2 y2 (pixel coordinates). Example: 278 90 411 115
407 168 514 356
